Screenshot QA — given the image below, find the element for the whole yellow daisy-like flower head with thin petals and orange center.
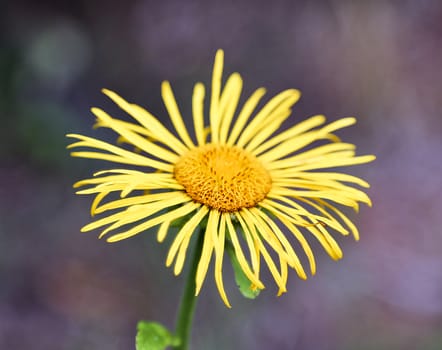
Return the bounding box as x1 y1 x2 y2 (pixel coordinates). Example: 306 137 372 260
67 50 375 307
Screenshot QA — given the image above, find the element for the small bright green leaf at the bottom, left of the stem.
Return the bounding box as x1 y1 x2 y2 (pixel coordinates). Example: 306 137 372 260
135 321 180 350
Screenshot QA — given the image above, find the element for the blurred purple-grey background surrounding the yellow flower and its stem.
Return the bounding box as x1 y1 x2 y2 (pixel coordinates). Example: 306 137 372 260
0 0 442 350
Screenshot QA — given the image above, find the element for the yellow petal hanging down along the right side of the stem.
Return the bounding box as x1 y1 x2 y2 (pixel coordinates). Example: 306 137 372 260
195 210 220 295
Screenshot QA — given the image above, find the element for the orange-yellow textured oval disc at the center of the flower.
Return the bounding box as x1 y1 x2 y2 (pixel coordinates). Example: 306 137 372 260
174 144 272 212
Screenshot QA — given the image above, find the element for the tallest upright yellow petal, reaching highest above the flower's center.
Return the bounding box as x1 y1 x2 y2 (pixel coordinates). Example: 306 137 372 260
210 50 224 143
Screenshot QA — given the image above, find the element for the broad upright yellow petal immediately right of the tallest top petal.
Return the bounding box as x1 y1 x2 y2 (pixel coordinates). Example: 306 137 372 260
219 73 243 144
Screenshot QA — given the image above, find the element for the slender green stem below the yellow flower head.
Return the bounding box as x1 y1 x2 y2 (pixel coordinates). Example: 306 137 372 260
174 230 204 350
